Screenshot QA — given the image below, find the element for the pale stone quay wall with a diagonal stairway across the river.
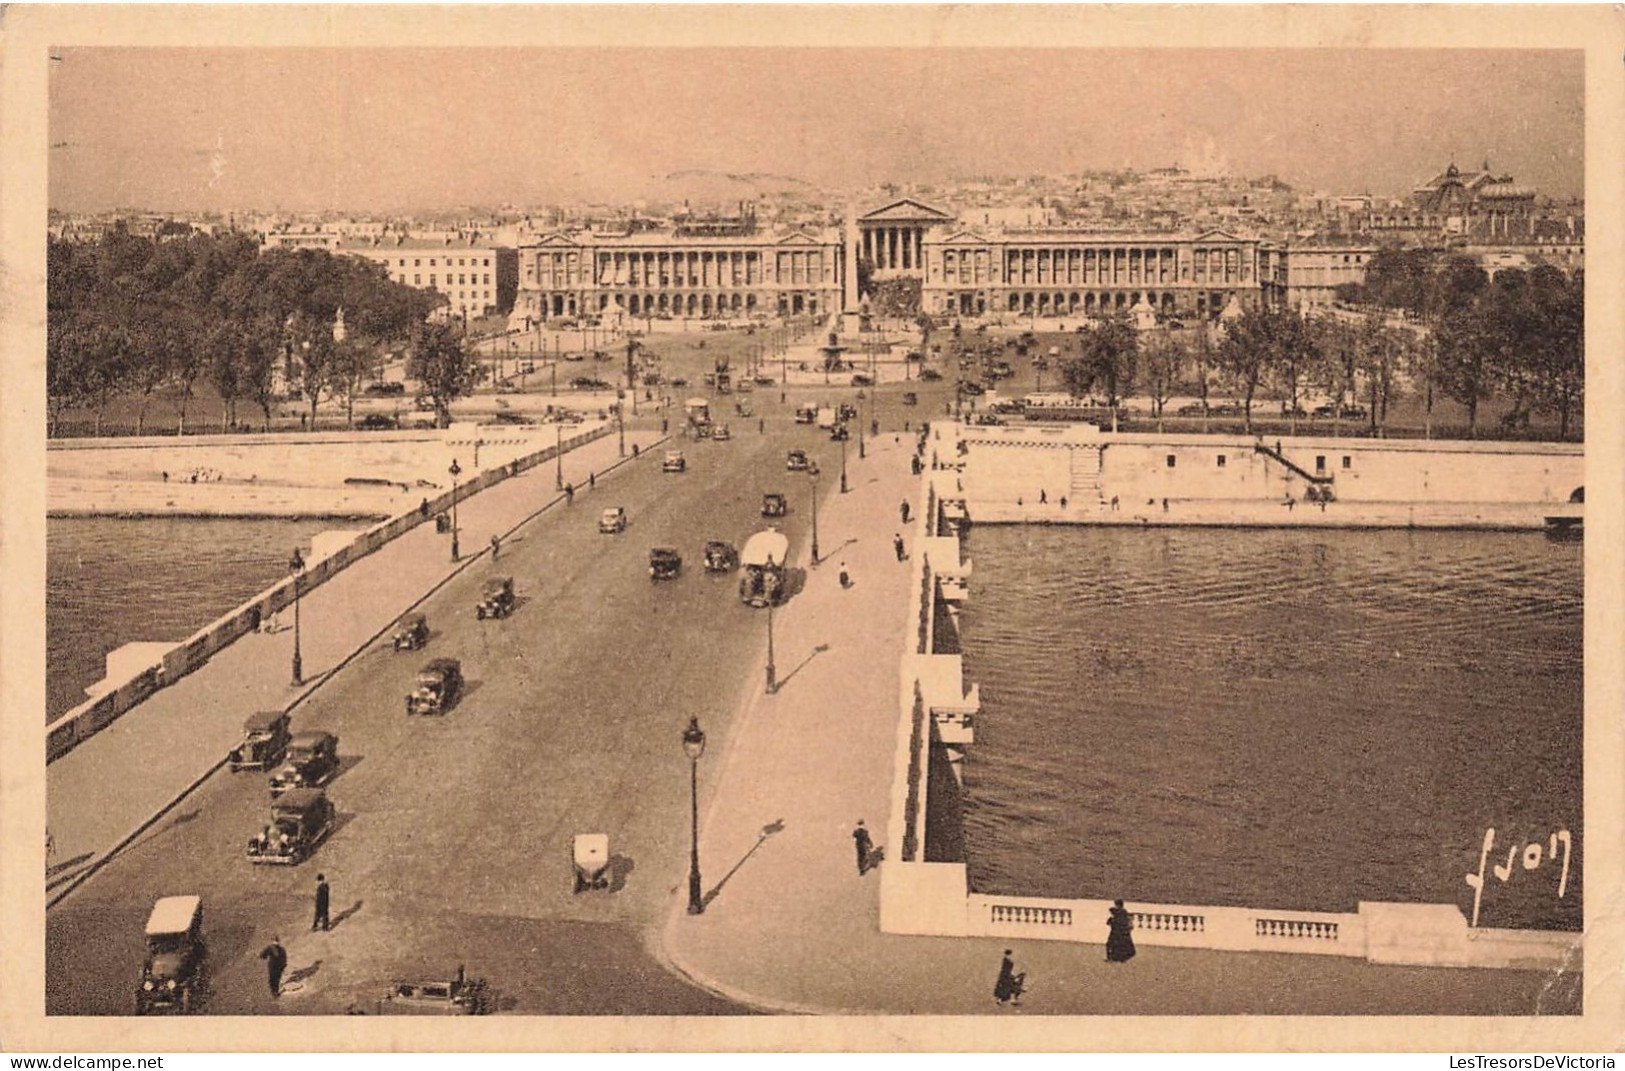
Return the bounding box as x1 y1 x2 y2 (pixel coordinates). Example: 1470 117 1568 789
931 424 1584 518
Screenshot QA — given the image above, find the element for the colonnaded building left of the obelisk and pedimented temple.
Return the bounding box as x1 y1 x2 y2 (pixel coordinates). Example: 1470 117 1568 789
514 231 847 323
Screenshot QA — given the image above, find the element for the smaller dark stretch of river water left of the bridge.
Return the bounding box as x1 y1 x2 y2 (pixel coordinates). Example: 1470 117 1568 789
46 517 344 722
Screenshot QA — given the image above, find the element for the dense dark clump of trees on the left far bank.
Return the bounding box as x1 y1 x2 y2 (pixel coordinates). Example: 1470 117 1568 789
46 226 475 434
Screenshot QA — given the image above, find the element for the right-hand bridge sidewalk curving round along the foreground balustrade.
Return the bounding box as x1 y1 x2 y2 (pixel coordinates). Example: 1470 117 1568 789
663 436 1583 1014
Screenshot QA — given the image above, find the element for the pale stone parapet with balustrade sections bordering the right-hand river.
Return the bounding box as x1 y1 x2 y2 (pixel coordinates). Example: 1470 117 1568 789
879 429 1584 970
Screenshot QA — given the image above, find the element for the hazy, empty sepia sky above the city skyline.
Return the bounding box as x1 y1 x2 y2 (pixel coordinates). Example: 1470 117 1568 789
50 47 1584 211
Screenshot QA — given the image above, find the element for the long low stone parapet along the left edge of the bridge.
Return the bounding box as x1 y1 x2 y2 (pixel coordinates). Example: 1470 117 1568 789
46 426 611 764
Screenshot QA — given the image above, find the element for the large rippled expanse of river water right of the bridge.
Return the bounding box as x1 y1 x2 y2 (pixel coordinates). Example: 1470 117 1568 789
962 525 1584 930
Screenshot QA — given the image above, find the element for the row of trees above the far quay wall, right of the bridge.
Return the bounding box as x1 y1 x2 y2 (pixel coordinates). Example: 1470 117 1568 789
1063 250 1584 437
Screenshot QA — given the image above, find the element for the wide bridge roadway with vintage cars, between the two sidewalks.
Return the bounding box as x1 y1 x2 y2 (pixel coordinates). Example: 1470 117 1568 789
46 403 839 1014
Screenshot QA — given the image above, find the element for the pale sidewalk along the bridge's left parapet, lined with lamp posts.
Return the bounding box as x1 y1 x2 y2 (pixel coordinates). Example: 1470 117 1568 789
46 429 661 900
